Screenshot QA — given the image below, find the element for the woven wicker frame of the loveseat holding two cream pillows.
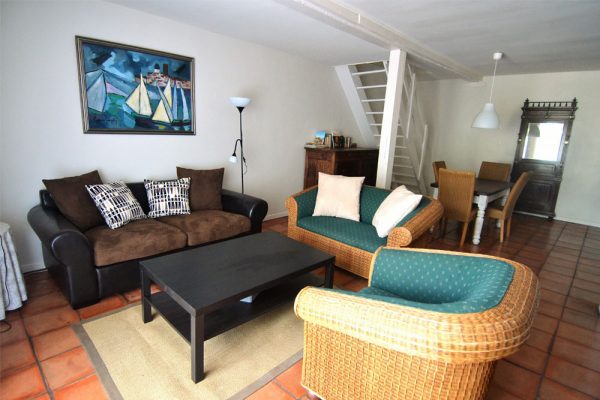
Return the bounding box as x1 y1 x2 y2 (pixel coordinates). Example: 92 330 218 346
285 186 444 278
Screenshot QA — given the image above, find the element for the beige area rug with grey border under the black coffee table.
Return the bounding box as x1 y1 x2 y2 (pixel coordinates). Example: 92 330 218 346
75 303 303 400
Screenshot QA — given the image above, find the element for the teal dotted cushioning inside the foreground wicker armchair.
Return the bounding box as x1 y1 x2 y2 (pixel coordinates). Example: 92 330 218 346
340 249 514 314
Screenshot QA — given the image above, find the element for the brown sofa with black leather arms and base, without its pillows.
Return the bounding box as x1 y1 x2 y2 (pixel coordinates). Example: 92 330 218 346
27 182 268 308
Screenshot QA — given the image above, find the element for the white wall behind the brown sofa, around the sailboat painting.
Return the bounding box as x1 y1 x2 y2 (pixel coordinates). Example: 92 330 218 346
0 1 359 271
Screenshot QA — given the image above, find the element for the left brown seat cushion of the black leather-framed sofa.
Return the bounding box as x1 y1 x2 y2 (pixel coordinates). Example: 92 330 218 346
85 219 187 267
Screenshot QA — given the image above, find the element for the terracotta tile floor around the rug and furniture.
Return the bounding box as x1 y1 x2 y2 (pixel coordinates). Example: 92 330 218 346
0 215 600 400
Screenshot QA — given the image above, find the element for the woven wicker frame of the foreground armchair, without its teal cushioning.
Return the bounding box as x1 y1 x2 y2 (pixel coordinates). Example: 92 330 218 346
295 249 539 400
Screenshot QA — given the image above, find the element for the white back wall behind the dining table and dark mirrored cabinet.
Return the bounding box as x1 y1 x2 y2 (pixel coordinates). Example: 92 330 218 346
418 71 600 226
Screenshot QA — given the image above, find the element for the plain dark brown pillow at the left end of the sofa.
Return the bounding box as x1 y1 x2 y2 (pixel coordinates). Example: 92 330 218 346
42 171 104 231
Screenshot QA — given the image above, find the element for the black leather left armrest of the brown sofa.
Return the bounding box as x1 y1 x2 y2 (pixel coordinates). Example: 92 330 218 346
27 205 99 307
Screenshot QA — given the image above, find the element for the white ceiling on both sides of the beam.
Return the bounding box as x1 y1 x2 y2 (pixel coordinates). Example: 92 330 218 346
109 0 600 75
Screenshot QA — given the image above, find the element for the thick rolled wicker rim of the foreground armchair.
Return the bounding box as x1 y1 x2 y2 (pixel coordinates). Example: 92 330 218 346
294 263 539 364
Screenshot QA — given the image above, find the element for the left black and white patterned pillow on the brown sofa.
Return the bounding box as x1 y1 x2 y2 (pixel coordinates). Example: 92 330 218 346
85 182 146 229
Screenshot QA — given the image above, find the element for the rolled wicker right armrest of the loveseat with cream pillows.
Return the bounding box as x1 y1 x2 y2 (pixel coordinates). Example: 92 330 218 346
387 198 444 247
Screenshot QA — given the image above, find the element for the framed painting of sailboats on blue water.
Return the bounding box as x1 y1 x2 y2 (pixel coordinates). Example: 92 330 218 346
75 36 195 135
